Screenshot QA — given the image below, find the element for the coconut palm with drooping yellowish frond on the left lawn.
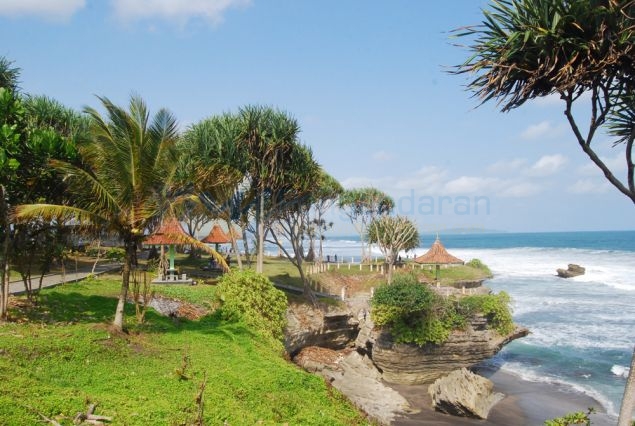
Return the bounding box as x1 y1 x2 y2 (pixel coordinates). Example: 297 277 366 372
15 96 183 330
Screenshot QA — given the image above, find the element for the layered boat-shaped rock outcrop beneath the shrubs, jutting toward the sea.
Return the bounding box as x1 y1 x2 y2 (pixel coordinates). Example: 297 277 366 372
366 317 529 384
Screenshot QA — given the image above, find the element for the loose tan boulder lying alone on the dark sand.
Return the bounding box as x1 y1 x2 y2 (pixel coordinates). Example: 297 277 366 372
428 368 505 419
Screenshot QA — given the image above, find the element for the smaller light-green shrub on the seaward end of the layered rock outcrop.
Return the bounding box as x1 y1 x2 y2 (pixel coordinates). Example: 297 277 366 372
458 291 514 335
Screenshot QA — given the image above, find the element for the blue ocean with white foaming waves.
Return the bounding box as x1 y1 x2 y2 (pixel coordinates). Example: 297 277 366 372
324 231 635 415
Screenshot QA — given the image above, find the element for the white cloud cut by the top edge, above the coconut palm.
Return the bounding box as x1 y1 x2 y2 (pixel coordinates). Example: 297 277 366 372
112 0 251 25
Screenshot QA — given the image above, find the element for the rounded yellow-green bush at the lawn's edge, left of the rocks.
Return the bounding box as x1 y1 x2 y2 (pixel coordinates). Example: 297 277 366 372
216 270 287 340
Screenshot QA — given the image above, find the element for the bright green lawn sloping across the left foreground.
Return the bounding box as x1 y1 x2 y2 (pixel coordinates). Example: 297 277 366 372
0 277 367 425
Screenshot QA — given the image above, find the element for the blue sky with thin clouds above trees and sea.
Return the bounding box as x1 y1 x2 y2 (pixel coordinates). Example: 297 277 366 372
0 0 635 234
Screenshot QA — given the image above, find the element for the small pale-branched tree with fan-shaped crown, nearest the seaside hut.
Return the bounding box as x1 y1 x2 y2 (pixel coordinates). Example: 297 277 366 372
368 216 419 284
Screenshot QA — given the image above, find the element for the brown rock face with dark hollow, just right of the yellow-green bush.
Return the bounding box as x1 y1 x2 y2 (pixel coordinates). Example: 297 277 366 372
284 304 359 356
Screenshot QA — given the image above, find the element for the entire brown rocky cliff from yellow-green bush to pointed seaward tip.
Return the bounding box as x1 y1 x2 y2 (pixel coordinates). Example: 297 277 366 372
285 303 529 384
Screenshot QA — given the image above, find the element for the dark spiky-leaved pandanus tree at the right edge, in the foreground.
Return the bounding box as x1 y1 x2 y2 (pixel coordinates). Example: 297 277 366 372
453 0 635 425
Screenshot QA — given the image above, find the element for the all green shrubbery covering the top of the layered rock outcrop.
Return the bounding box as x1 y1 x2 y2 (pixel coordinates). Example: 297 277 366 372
371 274 514 345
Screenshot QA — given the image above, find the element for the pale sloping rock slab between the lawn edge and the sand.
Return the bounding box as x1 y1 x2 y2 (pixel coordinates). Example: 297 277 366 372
294 347 412 425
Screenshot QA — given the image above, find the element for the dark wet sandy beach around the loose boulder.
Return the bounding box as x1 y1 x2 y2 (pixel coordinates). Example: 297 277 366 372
390 370 617 426
